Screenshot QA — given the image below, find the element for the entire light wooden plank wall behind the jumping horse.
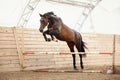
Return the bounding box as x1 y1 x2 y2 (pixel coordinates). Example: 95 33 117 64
0 27 120 72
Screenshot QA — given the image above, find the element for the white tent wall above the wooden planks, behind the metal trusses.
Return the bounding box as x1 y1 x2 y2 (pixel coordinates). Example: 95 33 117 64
0 0 120 34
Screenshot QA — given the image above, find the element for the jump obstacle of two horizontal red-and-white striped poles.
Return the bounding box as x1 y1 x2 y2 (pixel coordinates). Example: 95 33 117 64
23 52 112 73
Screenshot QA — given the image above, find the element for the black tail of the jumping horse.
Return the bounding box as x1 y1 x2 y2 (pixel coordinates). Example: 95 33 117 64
76 33 87 52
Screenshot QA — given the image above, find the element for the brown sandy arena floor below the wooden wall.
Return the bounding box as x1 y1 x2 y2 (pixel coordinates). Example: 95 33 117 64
0 71 120 80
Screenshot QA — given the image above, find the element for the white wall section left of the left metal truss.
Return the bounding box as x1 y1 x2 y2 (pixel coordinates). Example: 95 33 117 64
0 0 28 26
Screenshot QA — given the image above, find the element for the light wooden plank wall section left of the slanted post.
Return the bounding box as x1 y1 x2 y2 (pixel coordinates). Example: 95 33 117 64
0 27 20 72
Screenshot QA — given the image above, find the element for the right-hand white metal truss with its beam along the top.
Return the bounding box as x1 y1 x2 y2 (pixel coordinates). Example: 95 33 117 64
46 0 101 31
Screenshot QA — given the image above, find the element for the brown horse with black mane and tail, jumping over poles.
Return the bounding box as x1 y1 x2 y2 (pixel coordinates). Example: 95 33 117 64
39 12 87 70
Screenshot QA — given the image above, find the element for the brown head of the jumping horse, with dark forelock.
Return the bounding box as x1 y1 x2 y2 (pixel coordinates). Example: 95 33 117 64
39 12 54 32
